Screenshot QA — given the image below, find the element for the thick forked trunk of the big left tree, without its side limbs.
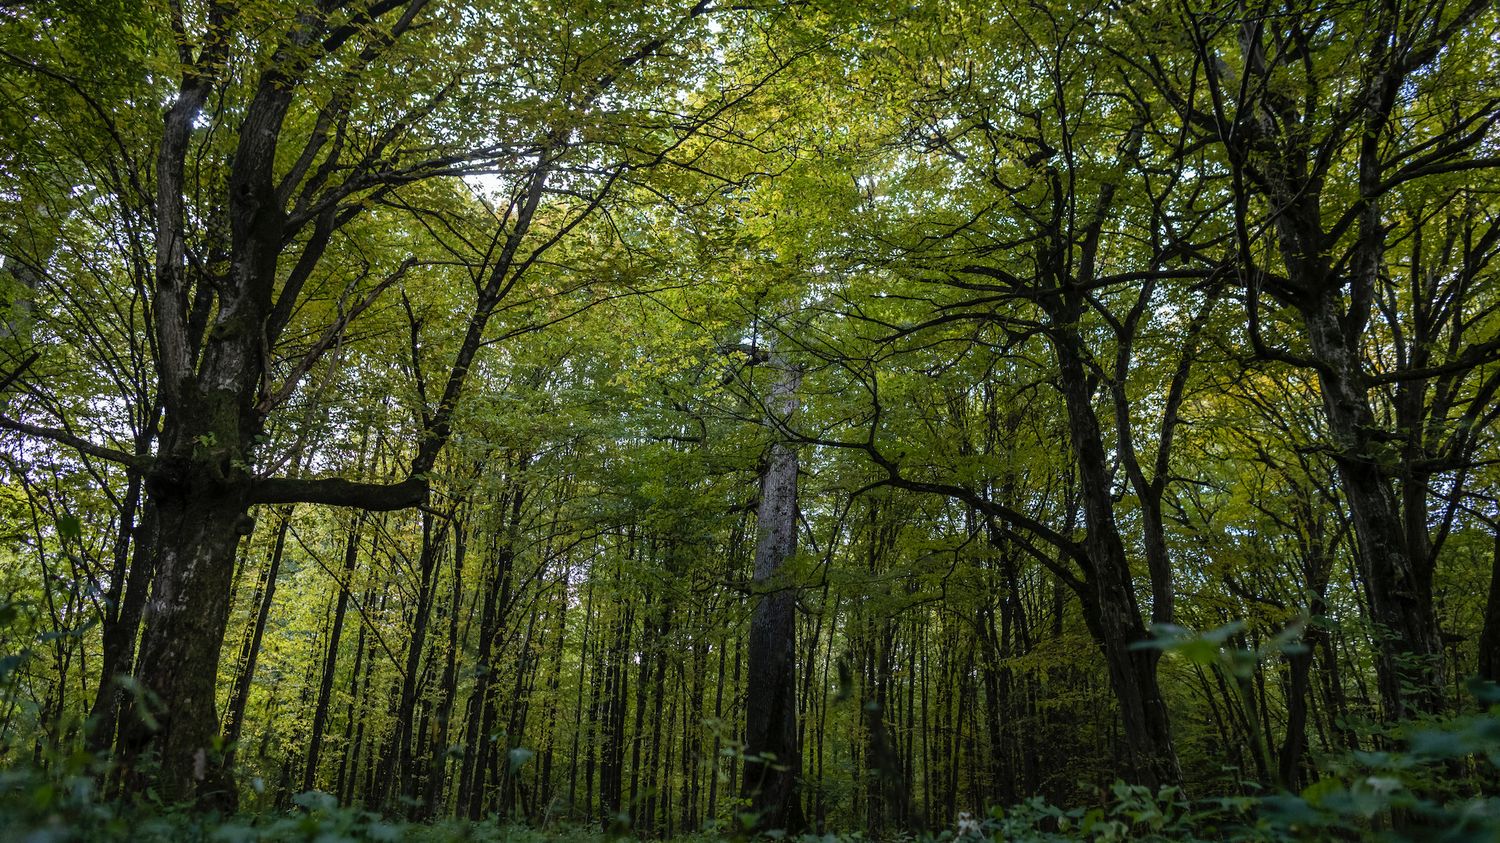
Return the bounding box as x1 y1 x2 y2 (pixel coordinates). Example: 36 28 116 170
120 6 276 792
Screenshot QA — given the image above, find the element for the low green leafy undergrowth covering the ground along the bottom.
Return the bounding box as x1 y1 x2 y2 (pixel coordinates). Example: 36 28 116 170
0 681 1500 843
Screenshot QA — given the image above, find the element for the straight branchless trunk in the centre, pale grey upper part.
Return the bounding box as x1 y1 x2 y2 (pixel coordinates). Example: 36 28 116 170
744 362 806 833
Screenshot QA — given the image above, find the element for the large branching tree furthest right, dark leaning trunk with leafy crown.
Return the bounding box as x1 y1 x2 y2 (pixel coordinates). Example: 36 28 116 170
1136 3 1500 719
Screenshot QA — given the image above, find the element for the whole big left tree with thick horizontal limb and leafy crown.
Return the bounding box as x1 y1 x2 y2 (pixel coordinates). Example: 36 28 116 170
0 0 747 801
